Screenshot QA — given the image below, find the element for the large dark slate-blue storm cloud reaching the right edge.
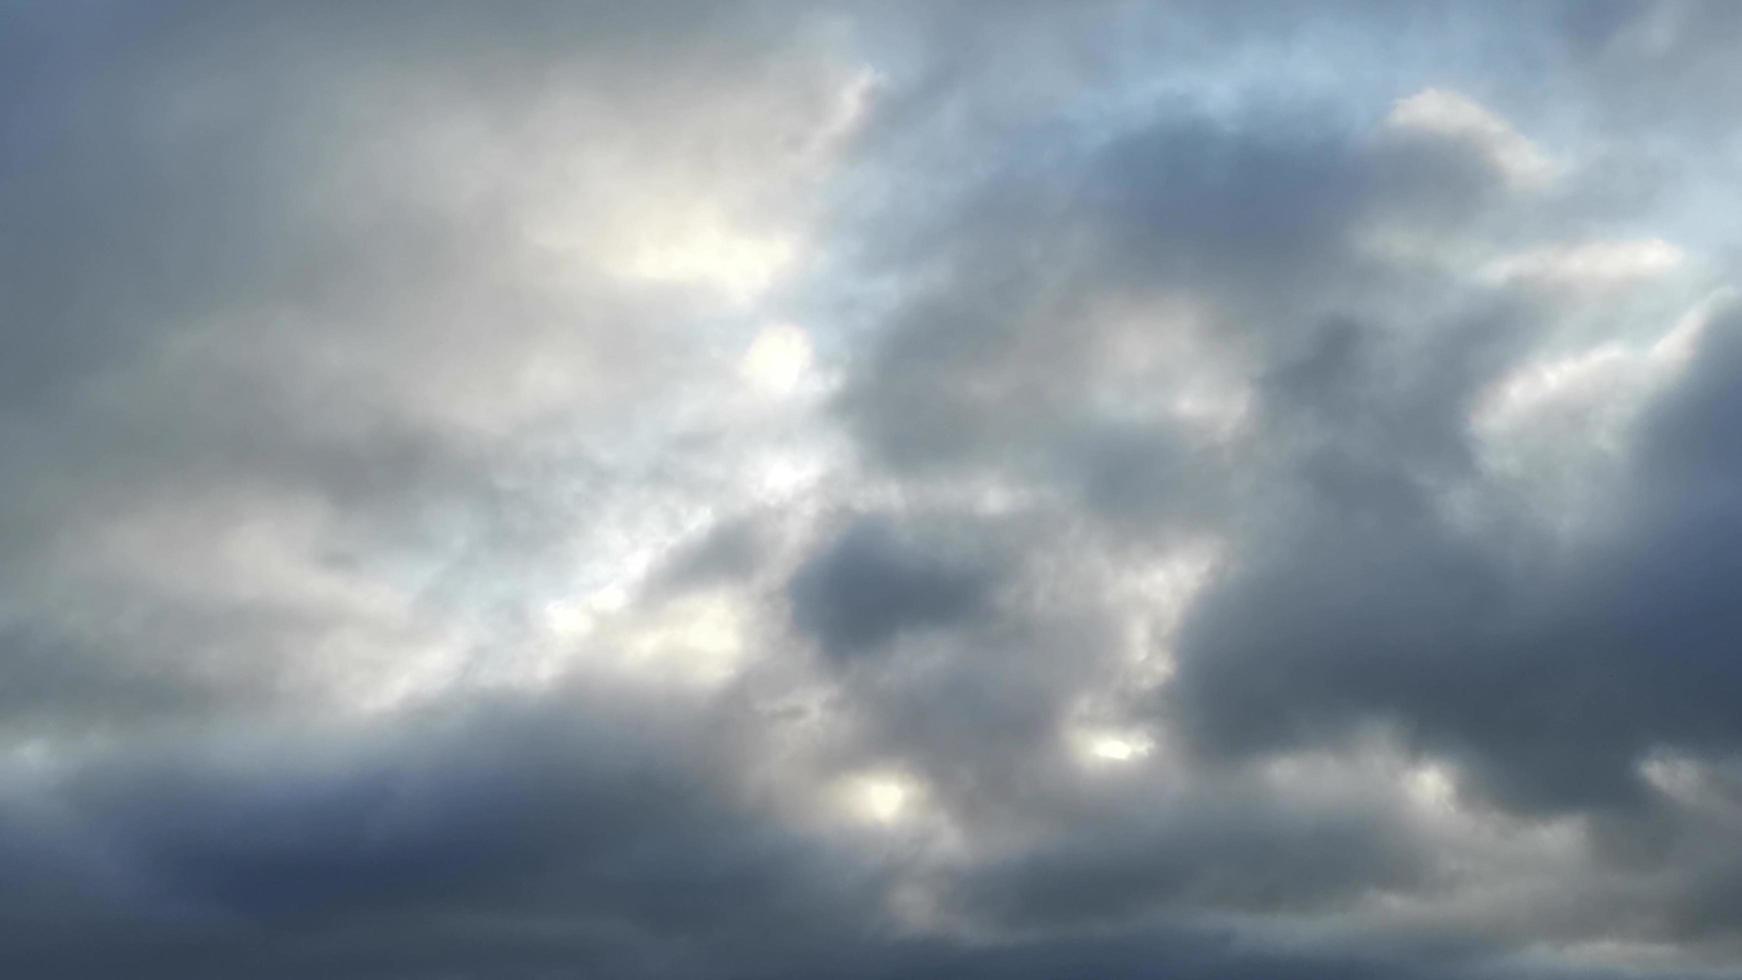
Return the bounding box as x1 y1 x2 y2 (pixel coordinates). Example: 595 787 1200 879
1171 302 1742 808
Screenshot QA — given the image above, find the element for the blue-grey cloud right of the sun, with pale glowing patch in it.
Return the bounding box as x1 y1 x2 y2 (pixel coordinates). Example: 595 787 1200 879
840 93 1528 513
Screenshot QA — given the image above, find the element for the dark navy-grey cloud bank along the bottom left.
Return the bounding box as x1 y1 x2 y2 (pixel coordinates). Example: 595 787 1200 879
0 682 878 975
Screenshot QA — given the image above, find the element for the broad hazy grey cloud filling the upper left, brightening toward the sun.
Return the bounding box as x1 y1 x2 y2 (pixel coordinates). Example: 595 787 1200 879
0 5 836 738
